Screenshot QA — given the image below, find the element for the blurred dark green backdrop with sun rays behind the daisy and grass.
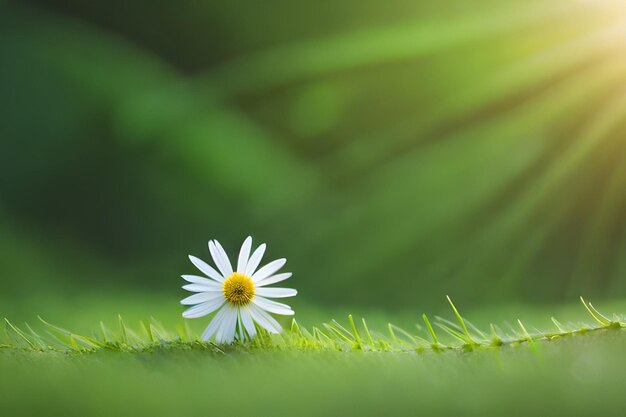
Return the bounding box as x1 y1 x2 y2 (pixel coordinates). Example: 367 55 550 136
0 0 626 324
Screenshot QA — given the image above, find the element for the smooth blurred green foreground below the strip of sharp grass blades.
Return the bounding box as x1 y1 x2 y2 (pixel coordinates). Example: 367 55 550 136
0 330 626 416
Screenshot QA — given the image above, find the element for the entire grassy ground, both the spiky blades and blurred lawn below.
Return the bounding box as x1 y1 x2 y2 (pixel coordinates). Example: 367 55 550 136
0 294 626 417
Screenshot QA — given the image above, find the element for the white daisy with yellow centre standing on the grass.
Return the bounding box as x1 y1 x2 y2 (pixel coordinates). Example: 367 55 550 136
180 236 298 343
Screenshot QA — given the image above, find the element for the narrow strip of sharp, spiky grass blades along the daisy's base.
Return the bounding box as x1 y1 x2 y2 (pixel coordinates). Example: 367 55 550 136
0 297 626 353
